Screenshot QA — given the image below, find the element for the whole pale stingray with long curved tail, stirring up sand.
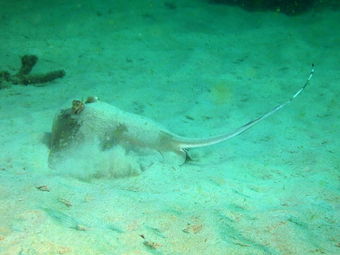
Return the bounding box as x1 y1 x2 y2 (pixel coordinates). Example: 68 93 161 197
50 65 314 166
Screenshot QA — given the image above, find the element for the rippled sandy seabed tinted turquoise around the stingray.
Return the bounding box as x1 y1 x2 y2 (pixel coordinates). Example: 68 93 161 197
0 0 340 255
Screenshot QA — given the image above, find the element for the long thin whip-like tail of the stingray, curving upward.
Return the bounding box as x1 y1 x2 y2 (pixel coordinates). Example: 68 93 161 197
176 64 314 149
